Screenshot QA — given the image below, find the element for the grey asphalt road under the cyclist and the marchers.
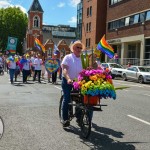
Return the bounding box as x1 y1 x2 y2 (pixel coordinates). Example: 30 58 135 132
0 74 150 150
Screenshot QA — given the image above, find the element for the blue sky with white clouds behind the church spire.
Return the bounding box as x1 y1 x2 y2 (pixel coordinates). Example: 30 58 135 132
0 0 80 27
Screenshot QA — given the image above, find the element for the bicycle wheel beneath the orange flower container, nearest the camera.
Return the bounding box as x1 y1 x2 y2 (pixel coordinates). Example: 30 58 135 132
80 110 91 139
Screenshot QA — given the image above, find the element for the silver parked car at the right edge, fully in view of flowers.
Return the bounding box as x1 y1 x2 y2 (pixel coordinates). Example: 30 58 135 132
122 66 150 83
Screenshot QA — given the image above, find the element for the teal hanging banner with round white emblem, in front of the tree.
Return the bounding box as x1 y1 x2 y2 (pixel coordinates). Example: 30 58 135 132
7 37 18 54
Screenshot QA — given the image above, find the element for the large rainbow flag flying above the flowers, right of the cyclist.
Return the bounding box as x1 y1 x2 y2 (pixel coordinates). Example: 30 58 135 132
97 35 114 58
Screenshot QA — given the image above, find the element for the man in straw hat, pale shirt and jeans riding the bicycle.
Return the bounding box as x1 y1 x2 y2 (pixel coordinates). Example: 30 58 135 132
61 40 85 127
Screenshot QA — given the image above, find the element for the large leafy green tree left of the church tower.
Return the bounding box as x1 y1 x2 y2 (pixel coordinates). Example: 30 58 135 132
0 7 28 54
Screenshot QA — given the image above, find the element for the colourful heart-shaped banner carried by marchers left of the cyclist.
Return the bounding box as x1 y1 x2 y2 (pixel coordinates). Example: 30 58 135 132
45 58 60 74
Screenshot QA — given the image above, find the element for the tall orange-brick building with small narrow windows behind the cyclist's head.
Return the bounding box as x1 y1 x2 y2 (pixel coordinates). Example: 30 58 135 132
81 0 107 50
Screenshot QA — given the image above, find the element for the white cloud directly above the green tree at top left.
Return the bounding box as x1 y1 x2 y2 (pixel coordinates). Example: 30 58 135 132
0 0 27 13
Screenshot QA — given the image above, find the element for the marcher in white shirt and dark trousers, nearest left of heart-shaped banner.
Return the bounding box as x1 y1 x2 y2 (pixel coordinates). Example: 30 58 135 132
33 54 43 83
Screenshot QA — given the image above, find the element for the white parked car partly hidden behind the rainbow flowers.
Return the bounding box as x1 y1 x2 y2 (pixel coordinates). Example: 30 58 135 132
101 63 125 79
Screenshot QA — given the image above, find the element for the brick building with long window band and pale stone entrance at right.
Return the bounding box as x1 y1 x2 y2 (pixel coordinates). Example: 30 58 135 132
106 0 150 65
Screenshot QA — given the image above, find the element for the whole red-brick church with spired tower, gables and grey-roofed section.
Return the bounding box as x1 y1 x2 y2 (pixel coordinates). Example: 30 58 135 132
25 0 76 57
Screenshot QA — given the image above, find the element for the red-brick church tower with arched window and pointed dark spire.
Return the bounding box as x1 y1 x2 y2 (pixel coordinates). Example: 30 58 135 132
26 0 44 50
